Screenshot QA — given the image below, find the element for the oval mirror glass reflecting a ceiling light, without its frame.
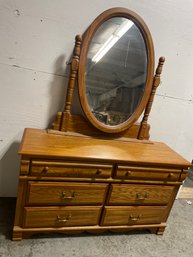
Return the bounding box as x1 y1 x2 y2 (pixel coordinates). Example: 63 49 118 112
85 17 147 126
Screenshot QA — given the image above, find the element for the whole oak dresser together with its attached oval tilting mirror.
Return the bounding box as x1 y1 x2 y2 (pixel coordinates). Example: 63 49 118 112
13 8 190 240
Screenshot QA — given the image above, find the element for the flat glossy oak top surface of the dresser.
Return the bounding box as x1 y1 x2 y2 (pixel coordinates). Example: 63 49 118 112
19 128 191 168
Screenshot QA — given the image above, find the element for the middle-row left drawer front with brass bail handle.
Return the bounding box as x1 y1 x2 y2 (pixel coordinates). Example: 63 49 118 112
27 182 108 205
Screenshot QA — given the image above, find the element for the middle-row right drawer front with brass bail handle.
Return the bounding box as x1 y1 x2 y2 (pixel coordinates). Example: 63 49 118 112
108 184 175 205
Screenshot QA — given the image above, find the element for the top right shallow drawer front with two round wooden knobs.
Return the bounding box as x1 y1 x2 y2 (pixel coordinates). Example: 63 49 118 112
115 165 181 181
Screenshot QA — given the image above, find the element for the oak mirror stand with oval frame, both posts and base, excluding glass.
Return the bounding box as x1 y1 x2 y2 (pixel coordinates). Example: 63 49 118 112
52 8 165 140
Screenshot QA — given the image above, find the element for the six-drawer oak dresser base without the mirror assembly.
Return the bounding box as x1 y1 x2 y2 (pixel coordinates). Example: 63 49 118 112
13 129 189 240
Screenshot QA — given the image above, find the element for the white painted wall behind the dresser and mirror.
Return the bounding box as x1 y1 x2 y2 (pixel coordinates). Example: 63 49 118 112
0 0 193 196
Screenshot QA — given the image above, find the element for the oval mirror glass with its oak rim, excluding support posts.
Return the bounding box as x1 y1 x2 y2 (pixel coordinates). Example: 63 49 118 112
78 8 154 133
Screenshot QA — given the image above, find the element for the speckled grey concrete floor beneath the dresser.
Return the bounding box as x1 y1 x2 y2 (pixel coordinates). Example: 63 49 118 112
0 199 193 257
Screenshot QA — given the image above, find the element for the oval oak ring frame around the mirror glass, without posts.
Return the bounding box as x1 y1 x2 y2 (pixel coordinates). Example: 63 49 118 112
78 7 154 133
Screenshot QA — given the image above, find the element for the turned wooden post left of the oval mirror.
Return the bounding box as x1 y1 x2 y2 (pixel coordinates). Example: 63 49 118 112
60 35 82 131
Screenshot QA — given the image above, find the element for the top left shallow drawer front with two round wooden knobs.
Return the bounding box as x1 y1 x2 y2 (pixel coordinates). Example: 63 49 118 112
30 160 112 179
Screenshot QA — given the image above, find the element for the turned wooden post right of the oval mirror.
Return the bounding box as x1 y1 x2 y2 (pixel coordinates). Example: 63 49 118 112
138 57 165 140
